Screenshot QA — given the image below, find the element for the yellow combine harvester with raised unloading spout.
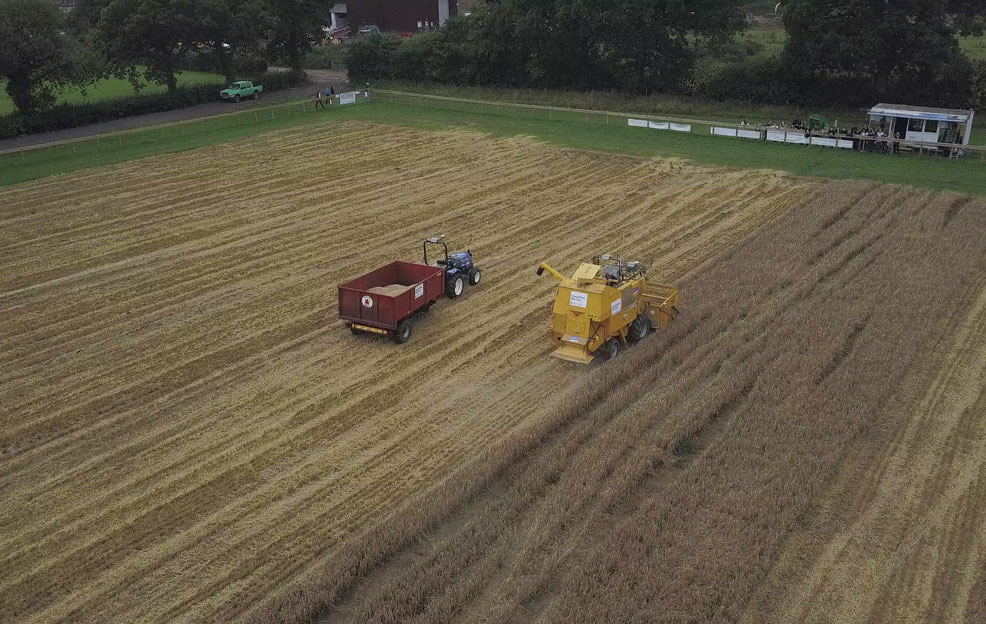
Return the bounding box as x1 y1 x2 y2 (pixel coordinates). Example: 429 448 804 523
538 255 678 364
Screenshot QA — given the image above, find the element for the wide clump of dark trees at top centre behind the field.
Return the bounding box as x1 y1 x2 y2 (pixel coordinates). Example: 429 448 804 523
439 0 743 92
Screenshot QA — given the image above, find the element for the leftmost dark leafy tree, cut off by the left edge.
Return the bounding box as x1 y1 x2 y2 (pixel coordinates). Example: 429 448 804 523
0 0 71 113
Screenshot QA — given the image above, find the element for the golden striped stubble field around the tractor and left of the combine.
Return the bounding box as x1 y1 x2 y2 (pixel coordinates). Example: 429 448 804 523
0 124 816 622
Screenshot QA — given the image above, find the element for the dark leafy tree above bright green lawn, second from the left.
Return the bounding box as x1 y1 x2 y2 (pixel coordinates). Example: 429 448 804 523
95 0 204 93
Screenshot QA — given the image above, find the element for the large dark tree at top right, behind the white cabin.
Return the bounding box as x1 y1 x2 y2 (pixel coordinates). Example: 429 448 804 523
783 0 986 100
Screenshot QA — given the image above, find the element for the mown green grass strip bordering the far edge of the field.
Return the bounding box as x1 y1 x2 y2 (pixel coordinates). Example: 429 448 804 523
0 91 986 195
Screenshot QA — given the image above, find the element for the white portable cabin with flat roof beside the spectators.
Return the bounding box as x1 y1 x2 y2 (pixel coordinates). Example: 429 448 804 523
870 104 976 145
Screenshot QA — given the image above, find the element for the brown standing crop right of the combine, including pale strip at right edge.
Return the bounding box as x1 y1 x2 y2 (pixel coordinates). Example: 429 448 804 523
314 183 986 624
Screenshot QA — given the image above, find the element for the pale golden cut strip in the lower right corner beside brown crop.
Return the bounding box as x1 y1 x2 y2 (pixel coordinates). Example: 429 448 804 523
746 278 986 622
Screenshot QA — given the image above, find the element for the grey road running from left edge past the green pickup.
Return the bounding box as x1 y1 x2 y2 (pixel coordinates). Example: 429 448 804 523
0 69 346 152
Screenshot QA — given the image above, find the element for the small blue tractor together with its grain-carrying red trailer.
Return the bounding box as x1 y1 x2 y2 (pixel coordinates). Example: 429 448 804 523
339 238 480 344
